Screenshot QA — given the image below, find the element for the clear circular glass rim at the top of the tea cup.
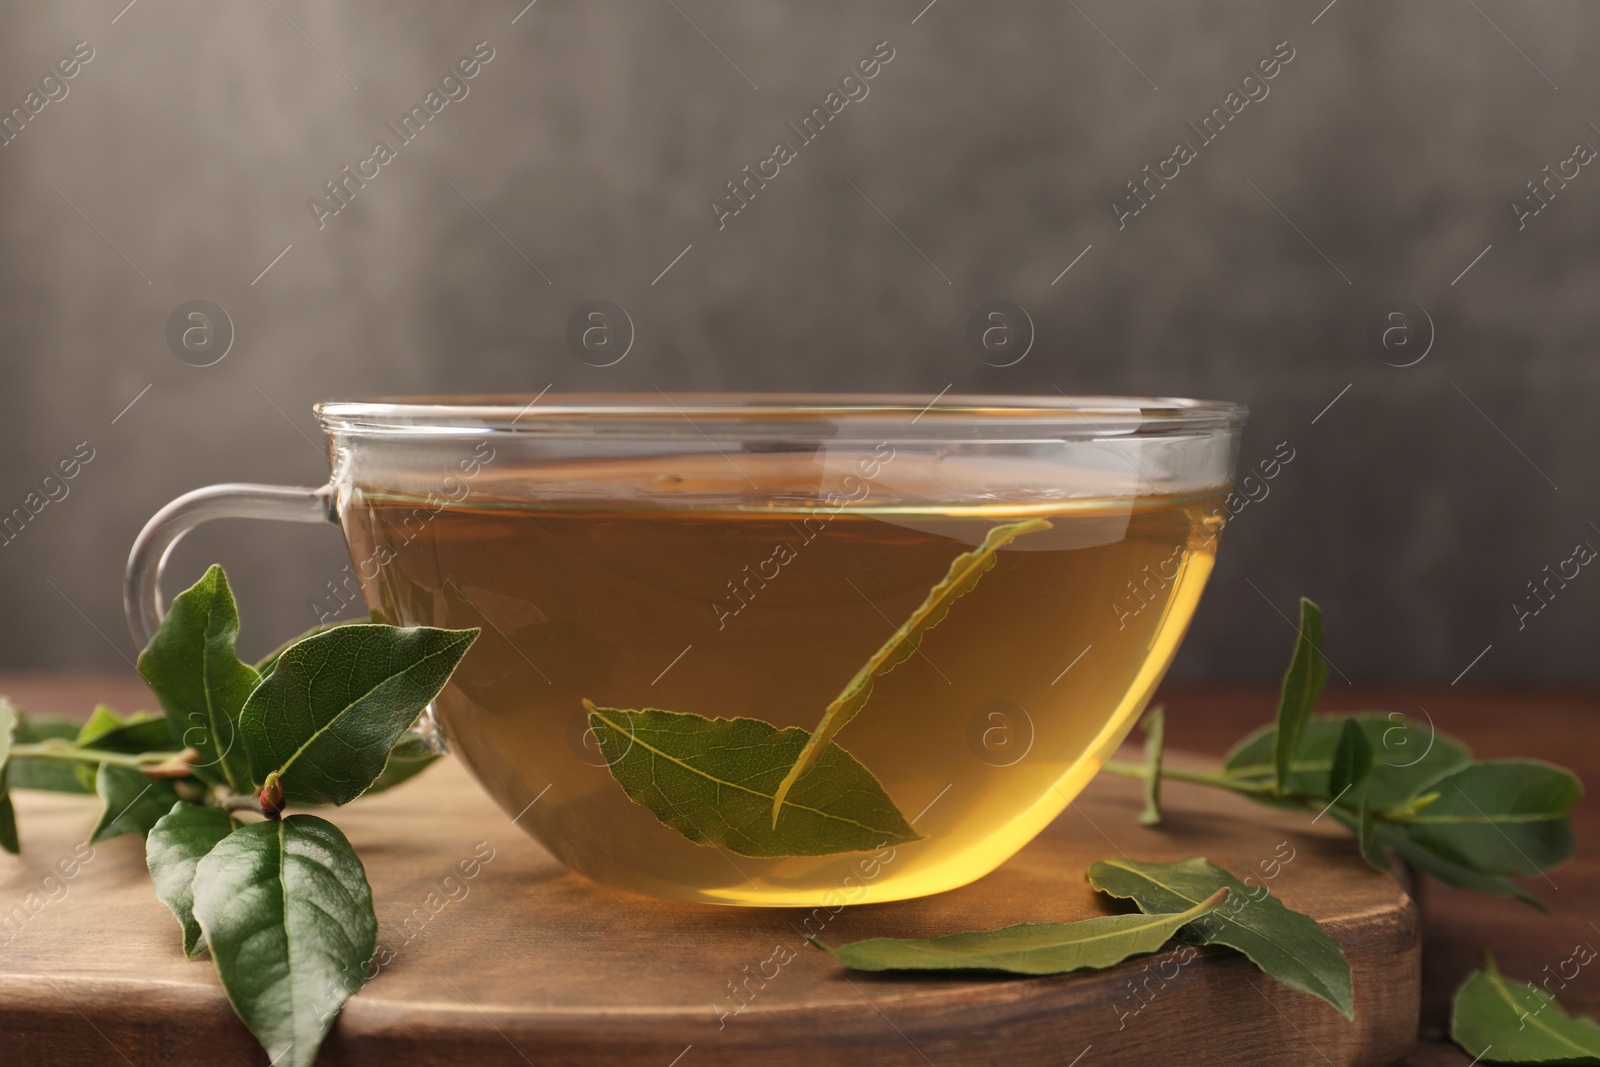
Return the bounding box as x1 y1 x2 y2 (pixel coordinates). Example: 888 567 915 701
312 390 1250 437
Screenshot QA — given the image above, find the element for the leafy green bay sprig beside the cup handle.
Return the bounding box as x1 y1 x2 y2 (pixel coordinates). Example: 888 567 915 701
0 566 478 1067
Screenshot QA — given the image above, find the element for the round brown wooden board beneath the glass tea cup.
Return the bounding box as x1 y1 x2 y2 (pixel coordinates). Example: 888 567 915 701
0 760 1421 1067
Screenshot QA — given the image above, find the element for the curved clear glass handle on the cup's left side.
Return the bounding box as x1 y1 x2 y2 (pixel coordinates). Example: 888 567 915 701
122 483 339 648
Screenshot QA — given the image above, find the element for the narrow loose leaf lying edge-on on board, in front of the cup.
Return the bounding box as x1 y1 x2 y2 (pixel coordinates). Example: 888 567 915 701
822 889 1227 974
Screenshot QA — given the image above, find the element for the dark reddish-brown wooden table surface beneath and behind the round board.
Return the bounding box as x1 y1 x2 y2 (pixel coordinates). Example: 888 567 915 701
0 672 1600 1067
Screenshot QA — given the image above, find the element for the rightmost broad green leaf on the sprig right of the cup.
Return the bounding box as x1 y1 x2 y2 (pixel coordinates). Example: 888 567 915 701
1402 760 1584 877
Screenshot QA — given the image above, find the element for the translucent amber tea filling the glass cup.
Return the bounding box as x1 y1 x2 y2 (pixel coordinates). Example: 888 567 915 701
341 450 1224 905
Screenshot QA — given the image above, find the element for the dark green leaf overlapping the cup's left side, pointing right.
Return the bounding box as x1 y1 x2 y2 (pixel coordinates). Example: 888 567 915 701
240 622 478 805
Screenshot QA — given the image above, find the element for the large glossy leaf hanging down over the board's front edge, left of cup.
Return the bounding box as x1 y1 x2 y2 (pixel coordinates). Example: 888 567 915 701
194 819 378 1067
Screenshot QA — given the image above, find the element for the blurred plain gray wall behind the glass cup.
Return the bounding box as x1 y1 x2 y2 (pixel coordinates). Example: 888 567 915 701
0 0 1600 685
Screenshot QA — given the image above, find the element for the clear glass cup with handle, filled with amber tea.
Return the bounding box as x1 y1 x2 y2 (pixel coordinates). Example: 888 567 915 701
125 394 1245 907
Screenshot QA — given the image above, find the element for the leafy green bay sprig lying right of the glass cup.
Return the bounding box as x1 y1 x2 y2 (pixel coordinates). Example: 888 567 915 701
1104 600 1582 909
